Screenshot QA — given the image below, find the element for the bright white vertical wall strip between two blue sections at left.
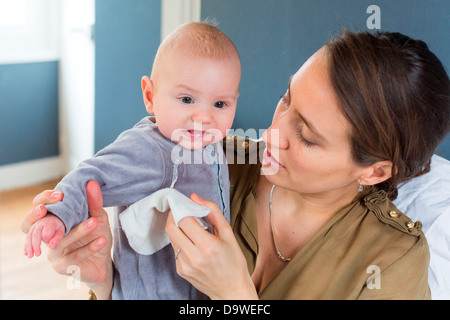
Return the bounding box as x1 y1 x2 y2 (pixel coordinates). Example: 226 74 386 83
59 0 95 172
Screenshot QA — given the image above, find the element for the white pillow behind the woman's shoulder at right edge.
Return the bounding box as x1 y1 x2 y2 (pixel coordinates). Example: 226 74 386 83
394 155 450 300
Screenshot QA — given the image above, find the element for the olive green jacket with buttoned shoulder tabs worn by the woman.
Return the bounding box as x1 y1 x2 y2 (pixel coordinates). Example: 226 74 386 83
224 136 430 299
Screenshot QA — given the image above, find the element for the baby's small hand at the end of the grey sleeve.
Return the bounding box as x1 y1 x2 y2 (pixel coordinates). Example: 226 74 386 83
25 214 66 258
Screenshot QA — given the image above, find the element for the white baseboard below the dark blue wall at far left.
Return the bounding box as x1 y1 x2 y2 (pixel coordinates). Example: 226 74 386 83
0 157 65 191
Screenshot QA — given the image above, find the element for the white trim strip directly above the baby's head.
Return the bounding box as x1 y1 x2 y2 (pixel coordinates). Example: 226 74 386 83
161 0 202 41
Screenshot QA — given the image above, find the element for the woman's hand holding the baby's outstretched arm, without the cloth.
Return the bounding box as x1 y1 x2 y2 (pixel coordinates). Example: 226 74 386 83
22 181 113 298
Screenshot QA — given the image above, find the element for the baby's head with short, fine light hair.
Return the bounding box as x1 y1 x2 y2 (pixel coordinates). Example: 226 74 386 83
142 22 241 149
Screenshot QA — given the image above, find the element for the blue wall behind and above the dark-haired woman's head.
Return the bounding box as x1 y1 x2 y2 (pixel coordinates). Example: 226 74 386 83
202 0 450 159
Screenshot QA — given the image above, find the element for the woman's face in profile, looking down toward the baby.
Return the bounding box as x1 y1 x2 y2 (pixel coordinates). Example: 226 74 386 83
262 49 363 194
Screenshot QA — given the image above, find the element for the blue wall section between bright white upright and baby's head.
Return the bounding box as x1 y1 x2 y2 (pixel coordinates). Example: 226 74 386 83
95 0 161 151
